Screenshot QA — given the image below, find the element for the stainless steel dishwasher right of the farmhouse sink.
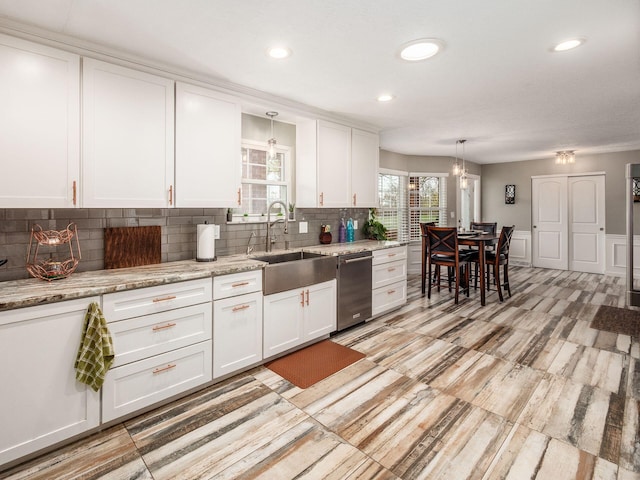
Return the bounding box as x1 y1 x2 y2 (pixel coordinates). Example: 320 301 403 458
337 252 371 331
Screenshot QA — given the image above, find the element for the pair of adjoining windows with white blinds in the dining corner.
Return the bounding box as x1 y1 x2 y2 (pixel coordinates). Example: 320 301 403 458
378 169 447 241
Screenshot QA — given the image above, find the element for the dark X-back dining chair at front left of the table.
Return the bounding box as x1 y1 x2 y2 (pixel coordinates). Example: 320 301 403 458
427 226 470 303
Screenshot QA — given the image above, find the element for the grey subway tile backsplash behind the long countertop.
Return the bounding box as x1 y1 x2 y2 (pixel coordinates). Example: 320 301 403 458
0 208 369 281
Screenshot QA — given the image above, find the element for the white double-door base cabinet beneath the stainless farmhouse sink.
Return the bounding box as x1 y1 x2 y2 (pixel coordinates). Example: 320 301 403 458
264 280 337 358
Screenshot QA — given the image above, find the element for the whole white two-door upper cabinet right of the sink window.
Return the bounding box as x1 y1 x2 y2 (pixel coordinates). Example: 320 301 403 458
296 120 379 208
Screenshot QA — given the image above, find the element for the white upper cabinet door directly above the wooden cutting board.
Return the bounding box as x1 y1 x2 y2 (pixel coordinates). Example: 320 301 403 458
81 58 174 208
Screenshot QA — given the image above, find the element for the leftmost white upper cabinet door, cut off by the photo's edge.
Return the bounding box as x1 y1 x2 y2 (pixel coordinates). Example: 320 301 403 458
0 35 80 208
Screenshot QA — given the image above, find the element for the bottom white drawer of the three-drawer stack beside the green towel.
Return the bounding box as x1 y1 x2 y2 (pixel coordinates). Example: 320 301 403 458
102 340 212 422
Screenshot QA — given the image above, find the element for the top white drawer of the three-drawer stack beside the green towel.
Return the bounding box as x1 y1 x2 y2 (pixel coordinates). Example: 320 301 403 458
102 278 212 322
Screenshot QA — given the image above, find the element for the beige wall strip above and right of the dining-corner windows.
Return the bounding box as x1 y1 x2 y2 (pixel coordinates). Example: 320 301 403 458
380 150 484 226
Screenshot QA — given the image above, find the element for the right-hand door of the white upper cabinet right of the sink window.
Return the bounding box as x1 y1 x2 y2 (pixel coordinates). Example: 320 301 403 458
351 128 380 207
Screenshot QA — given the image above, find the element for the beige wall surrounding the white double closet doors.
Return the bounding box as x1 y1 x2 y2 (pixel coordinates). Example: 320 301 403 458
481 150 640 235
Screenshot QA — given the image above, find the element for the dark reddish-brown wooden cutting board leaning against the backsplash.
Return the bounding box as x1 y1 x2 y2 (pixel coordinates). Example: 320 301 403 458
104 225 162 269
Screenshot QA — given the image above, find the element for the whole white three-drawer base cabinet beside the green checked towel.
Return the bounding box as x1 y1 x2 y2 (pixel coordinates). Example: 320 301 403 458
102 278 213 422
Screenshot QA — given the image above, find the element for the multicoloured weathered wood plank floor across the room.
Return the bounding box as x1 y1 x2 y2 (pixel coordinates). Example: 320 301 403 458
0 268 640 480
